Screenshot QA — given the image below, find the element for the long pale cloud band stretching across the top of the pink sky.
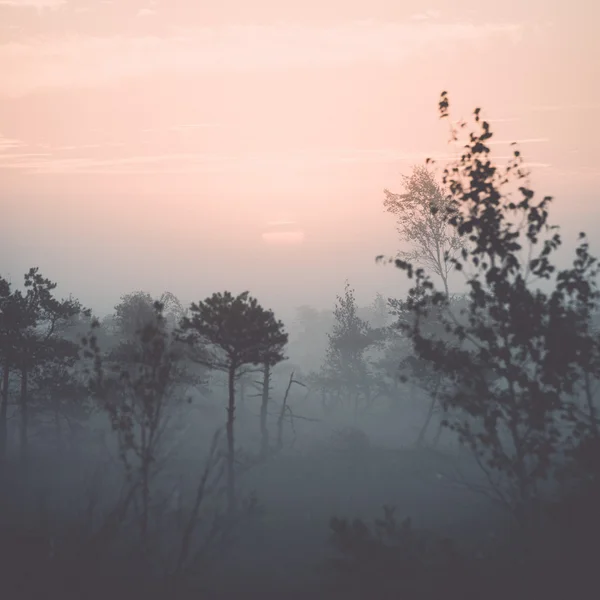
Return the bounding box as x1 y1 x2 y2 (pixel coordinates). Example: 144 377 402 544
0 19 522 96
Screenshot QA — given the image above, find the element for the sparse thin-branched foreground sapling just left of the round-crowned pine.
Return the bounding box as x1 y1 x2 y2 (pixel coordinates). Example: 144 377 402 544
74 302 234 597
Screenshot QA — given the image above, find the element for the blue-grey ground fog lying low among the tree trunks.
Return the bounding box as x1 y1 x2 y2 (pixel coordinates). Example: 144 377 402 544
2 291 509 598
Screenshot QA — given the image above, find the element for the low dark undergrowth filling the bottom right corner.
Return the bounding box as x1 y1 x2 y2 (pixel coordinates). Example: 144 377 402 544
329 491 599 600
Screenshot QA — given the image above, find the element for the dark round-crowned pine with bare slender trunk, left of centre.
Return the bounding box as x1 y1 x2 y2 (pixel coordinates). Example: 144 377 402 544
181 292 288 514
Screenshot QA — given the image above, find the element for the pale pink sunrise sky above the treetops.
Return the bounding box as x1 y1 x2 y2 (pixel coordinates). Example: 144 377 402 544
0 0 600 324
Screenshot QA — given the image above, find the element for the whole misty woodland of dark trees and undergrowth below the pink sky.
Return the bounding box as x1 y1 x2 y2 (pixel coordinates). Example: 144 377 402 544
0 94 600 600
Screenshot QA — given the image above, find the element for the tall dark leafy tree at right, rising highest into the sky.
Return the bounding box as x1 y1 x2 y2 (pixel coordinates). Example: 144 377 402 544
382 93 600 525
